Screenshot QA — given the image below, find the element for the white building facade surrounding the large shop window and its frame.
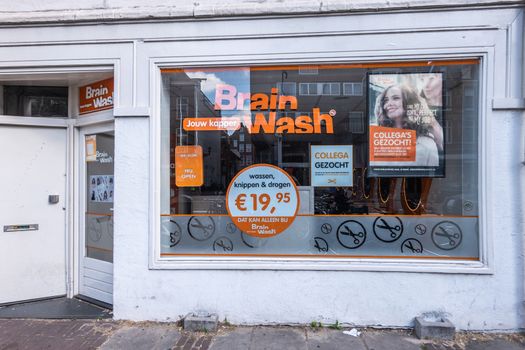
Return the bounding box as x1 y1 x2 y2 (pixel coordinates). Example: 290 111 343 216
0 1 525 330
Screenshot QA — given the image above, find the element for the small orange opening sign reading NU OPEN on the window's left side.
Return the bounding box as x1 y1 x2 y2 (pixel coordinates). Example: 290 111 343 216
175 146 204 187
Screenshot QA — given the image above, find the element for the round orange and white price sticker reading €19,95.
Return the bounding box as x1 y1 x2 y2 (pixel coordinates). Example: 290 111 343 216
226 164 299 238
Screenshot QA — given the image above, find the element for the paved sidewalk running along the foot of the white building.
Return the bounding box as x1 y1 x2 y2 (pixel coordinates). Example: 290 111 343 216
0 319 525 350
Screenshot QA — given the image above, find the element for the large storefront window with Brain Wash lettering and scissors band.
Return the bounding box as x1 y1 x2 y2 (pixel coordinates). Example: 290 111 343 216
160 59 479 261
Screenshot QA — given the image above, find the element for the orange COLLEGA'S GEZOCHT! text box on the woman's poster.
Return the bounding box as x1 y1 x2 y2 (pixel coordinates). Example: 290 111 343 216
370 125 416 162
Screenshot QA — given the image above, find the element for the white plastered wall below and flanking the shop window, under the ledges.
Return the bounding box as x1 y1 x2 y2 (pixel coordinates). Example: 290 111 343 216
114 113 524 330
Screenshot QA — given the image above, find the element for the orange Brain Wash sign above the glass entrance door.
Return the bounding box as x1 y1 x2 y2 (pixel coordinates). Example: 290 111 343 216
78 78 113 115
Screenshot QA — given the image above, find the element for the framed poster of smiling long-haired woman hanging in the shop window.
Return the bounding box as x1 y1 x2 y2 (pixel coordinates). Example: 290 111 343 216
368 73 445 177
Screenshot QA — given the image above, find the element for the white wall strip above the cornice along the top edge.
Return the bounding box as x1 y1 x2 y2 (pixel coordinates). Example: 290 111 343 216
0 0 522 24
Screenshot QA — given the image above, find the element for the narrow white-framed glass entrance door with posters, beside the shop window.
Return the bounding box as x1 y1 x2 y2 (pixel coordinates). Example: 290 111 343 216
79 125 115 304
